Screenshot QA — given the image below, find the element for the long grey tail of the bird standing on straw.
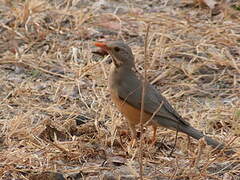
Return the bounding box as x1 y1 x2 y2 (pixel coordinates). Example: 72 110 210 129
179 126 224 150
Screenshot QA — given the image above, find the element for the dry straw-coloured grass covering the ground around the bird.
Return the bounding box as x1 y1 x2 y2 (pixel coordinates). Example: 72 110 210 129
0 0 240 179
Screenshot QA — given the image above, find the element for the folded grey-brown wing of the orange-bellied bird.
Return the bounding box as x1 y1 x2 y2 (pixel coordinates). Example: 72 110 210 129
117 69 189 125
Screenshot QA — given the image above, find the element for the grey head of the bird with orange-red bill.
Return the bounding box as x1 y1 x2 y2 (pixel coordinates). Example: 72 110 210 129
95 41 135 68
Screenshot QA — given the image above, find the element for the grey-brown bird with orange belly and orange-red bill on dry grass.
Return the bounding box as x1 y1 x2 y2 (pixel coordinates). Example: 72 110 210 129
94 40 232 154
